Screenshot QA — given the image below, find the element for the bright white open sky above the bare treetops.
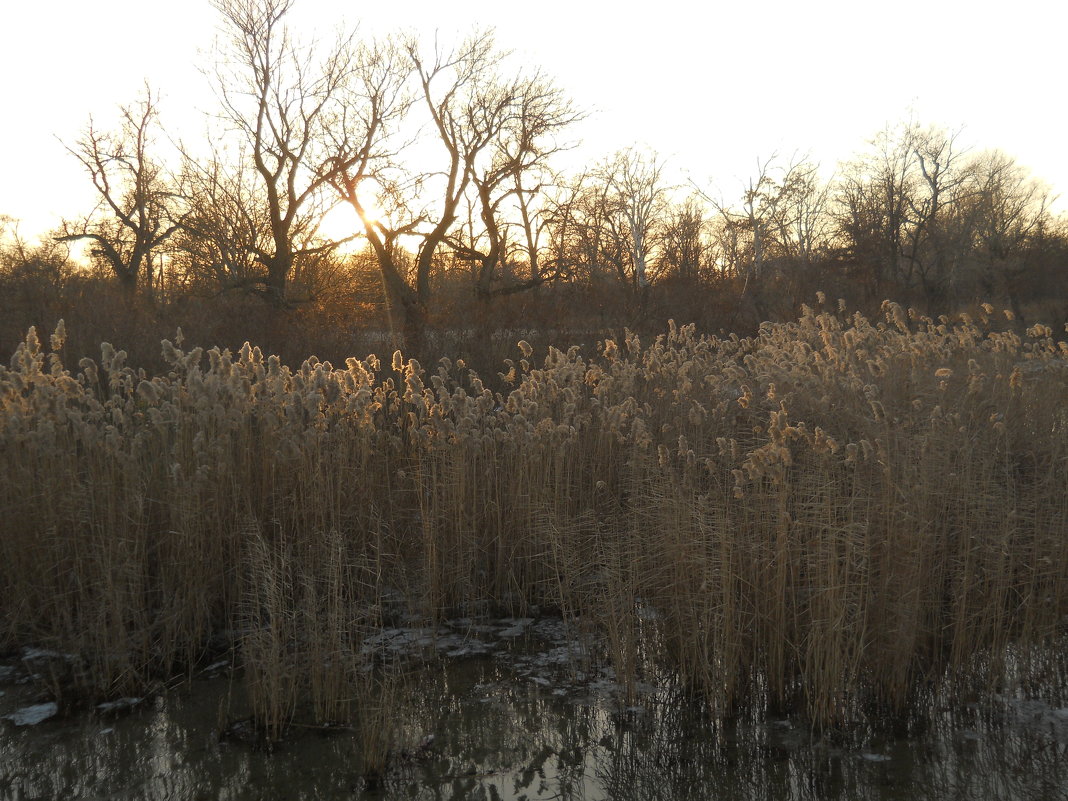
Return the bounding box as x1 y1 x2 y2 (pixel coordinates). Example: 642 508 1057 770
0 0 1068 235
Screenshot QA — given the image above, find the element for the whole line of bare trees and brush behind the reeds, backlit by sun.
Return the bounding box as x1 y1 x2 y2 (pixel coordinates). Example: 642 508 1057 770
0 0 1068 369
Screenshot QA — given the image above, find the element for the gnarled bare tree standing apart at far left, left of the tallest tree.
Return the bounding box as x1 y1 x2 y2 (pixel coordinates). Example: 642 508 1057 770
56 85 184 294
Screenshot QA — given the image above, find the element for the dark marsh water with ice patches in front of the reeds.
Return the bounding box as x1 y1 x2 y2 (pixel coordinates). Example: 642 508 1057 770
0 619 1068 801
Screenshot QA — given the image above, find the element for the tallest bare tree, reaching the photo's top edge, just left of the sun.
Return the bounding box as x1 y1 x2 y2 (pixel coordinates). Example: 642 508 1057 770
206 0 358 307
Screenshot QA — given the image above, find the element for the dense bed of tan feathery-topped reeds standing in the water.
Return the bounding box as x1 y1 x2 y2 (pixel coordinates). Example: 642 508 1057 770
0 299 1068 737
